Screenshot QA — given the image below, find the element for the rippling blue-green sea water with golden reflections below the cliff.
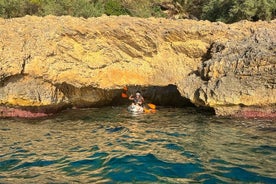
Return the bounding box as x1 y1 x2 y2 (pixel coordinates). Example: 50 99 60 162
0 107 276 183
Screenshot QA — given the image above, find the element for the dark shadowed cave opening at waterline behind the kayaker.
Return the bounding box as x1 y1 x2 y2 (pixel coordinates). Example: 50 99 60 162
52 83 215 114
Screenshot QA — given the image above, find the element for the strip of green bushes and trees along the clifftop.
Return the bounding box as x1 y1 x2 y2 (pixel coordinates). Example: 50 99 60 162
0 0 276 23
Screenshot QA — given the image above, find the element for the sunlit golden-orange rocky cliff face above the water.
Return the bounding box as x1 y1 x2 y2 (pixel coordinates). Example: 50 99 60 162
0 16 276 116
